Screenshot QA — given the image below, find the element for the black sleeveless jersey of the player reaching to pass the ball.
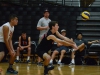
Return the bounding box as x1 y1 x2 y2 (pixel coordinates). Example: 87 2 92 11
37 30 55 51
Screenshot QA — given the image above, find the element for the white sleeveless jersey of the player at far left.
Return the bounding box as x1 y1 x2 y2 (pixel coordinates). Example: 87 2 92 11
0 22 14 42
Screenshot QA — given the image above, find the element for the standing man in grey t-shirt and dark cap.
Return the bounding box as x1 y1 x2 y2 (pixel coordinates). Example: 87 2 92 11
37 10 51 66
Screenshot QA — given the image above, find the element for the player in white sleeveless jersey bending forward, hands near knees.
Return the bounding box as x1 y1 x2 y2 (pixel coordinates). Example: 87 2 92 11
0 15 18 74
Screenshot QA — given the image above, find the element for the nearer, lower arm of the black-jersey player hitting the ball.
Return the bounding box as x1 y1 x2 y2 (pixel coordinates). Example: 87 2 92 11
47 35 73 46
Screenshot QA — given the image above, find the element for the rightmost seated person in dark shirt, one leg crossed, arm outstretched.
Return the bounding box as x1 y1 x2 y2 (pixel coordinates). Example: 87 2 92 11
69 33 98 65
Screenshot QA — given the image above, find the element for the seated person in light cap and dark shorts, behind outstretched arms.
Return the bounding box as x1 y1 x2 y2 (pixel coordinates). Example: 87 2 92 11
50 29 69 65
